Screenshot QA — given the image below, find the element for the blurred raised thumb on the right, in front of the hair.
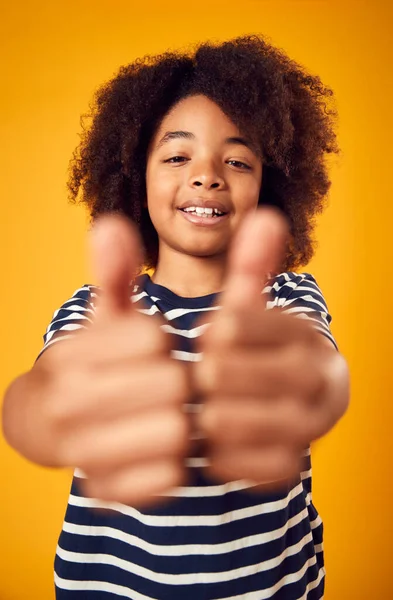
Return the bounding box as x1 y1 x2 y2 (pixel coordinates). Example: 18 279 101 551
221 207 289 308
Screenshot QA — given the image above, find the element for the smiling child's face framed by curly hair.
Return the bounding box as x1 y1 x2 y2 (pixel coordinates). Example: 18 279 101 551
146 95 262 257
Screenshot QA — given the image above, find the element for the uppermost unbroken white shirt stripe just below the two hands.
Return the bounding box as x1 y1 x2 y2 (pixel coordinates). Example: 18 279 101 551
69 483 303 527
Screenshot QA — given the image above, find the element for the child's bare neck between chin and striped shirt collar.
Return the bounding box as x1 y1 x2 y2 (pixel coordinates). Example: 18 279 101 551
151 246 230 298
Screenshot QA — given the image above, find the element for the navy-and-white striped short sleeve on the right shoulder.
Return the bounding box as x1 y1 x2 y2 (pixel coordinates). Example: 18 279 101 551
264 272 338 350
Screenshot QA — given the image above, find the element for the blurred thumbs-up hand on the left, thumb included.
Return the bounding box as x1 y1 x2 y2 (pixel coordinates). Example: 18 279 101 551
39 215 190 506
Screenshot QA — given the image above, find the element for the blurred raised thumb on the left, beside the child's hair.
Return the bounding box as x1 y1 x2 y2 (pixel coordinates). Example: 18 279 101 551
89 213 143 318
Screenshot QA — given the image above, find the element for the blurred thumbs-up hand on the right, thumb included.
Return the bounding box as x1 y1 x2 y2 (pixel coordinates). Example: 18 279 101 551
193 209 339 489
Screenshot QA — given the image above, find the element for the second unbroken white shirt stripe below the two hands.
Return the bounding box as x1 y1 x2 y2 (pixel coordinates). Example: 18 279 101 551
63 508 308 556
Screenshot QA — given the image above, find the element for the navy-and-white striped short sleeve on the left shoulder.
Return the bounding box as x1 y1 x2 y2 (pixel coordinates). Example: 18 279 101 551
36 284 97 361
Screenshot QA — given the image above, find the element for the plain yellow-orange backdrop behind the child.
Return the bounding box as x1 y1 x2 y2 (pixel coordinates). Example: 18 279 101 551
0 0 393 600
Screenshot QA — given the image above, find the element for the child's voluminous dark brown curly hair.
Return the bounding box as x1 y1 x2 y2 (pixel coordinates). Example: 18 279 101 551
67 35 340 270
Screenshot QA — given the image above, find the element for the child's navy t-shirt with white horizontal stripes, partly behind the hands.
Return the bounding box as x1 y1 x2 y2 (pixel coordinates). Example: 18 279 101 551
39 272 337 600
